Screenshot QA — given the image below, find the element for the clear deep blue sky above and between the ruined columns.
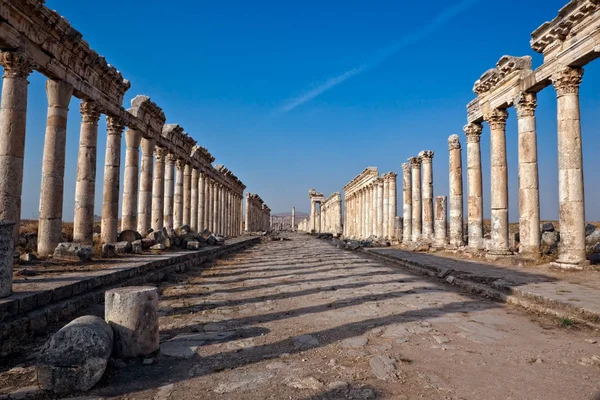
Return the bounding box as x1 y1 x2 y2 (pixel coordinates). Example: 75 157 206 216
8 0 600 221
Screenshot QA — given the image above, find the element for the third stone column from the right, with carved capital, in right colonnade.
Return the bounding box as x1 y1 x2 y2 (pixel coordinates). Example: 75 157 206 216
485 109 510 255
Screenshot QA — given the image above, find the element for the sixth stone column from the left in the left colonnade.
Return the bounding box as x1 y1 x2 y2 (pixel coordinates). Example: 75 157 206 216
137 138 156 236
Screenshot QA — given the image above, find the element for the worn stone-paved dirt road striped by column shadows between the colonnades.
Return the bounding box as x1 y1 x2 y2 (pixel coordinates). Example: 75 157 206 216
0 234 600 400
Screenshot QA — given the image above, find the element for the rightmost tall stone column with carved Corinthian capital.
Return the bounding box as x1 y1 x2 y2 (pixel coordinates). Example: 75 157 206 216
552 67 586 269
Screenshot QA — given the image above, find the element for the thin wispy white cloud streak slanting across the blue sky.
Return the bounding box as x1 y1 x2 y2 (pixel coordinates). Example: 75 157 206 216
279 0 480 113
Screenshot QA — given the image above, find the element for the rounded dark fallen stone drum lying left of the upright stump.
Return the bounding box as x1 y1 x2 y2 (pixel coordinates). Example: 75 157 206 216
36 315 113 395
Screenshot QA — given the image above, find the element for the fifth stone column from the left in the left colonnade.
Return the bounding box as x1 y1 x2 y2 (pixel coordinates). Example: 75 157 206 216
121 129 142 230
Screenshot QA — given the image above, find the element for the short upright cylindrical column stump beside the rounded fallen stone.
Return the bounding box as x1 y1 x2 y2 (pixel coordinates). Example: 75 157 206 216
104 286 159 357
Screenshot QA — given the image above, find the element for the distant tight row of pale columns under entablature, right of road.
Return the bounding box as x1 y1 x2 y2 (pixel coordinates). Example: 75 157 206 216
344 172 397 239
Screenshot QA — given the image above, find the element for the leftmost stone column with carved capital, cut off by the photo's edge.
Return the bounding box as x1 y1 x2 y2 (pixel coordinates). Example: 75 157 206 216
0 51 34 246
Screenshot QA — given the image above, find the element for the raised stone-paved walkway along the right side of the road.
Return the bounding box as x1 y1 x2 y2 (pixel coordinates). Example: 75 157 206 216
364 248 600 323
